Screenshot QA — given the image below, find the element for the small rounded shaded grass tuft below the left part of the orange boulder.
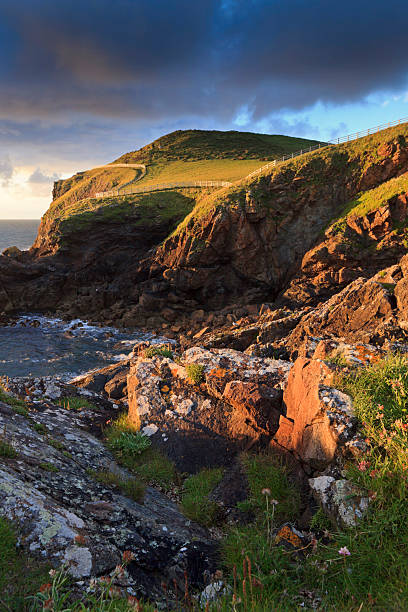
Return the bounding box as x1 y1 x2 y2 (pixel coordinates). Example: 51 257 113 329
181 468 222 527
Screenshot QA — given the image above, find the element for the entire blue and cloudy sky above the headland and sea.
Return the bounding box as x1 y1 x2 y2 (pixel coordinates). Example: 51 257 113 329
0 0 408 219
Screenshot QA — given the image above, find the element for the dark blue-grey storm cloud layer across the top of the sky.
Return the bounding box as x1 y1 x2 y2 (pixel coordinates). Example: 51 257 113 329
0 0 408 122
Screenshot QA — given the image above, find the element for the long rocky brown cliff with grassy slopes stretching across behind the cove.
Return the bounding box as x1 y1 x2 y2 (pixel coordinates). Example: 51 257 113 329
0 125 408 327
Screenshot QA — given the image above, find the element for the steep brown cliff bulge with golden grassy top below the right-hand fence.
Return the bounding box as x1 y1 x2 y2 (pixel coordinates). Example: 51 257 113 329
148 134 408 306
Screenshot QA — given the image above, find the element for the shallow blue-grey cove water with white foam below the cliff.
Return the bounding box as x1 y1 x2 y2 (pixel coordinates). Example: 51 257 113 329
0 315 163 378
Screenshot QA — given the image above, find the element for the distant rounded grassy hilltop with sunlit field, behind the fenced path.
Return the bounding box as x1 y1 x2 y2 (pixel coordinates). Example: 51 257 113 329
45 130 322 226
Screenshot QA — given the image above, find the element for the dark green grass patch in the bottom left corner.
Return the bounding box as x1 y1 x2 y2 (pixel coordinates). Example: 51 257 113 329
0 517 50 612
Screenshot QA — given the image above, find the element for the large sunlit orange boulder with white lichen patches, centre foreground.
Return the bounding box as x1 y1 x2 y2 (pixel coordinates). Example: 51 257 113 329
127 347 292 472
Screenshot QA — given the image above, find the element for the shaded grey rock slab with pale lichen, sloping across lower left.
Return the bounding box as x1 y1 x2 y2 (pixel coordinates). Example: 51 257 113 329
0 390 215 599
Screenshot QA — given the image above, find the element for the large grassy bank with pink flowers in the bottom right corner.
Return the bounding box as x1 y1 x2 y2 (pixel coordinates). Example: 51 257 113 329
215 356 408 612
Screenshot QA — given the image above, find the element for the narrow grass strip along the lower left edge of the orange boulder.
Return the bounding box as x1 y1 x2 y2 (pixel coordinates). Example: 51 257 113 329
105 414 179 490
